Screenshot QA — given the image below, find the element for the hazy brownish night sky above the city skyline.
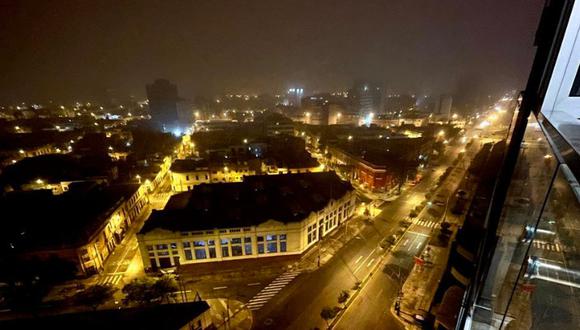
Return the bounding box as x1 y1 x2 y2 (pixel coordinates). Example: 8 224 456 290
0 0 544 103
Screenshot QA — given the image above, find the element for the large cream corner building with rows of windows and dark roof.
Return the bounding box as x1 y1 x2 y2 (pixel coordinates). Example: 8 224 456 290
138 172 356 269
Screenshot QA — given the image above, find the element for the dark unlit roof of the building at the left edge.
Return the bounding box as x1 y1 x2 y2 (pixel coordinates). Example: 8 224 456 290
0 183 139 251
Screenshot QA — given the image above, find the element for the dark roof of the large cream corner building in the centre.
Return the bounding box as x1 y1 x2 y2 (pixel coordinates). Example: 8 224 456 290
141 172 353 234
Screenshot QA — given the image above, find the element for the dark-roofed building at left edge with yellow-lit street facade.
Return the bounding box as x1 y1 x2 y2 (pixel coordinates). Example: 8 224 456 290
0 182 147 275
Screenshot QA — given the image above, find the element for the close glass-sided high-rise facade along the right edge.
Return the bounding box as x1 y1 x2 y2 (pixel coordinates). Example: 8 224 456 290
450 0 580 329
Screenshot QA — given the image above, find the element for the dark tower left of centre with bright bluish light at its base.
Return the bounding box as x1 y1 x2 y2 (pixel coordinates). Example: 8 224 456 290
147 79 183 135
